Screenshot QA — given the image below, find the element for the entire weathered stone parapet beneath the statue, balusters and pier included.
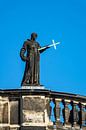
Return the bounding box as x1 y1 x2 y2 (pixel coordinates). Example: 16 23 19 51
0 89 86 130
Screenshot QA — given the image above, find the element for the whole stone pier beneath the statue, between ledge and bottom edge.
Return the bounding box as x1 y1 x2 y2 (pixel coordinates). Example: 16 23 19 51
21 95 53 130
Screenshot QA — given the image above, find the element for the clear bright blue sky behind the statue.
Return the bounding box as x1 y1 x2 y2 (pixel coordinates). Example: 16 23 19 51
0 0 86 95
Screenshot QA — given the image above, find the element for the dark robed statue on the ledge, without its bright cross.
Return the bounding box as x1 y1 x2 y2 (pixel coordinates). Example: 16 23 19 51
20 33 49 86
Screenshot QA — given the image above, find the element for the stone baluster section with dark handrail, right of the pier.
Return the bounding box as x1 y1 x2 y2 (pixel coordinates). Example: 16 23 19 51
51 92 86 129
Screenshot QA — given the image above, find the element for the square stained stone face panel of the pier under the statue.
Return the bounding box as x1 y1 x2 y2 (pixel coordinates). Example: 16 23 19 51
23 96 46 124
